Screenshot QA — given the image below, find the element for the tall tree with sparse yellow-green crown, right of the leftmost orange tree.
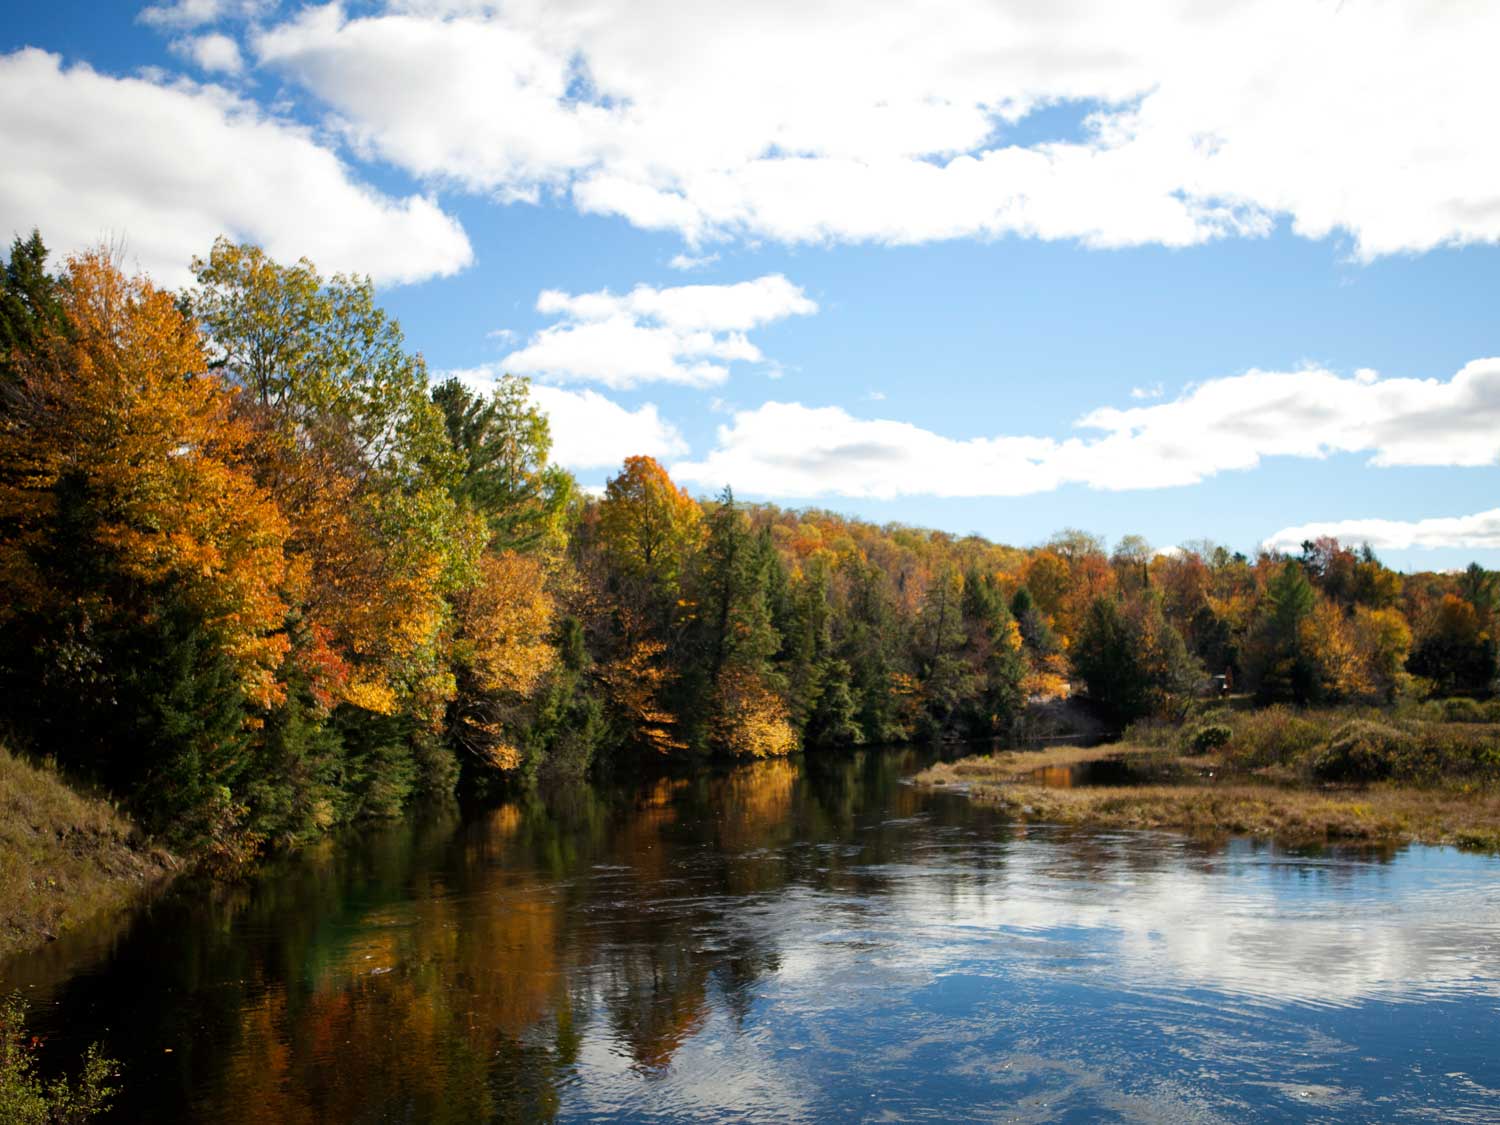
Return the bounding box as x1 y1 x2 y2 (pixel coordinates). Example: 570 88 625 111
192 239 465 722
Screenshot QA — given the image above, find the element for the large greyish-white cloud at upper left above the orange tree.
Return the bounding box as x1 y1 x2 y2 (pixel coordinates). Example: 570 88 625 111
0 48 473 285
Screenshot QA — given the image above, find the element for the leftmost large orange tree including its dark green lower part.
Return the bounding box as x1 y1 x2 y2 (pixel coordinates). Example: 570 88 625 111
0 254 293 840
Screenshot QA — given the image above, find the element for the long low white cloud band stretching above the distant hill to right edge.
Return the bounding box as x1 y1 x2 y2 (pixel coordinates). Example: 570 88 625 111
672 359 1500 498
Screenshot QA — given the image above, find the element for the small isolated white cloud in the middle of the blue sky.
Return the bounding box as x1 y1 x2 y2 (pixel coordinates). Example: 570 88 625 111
501 275 818 389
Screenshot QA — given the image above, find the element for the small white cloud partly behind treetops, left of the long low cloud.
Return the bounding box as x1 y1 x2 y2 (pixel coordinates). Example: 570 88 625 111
444 366 687 470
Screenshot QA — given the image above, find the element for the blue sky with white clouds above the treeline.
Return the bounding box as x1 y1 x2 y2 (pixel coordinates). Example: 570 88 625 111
0 0 1500 569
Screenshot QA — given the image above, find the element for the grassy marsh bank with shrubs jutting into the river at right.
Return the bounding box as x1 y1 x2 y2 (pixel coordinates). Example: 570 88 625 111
917 708 1500 849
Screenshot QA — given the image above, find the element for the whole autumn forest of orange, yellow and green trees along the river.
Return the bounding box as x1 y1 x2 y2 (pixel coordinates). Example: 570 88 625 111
0 234 1500 867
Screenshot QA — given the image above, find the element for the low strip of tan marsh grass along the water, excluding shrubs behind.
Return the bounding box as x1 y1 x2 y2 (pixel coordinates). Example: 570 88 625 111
914 743 1500 851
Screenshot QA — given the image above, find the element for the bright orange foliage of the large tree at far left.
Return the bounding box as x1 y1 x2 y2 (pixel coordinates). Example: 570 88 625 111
0 252 288 707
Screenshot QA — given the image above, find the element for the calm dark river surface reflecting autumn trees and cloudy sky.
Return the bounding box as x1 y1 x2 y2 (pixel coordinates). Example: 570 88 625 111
5 752 1500 1122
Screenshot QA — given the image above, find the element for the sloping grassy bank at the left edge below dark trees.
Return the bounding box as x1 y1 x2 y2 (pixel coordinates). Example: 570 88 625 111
0 747 182 957
